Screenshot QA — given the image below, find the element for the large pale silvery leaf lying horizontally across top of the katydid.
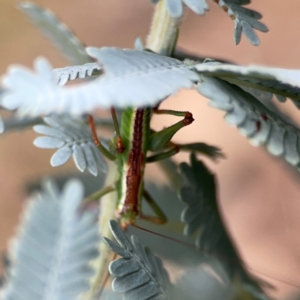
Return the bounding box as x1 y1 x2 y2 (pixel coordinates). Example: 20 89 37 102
2 48 199 116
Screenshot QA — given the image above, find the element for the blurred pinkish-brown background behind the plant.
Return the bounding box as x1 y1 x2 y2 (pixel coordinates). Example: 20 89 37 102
0 0 300 299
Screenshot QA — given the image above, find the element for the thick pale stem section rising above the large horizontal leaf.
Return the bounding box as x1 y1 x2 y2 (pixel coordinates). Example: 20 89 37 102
146 0 181 56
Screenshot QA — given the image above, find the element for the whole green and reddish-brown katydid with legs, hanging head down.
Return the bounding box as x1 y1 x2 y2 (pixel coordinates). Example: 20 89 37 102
89 108 194 228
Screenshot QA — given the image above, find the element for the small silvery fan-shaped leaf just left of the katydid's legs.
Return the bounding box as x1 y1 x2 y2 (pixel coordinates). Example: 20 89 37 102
33 116 106 176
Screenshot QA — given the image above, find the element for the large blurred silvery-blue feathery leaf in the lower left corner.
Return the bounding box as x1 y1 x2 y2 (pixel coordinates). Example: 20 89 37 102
2 180 99 300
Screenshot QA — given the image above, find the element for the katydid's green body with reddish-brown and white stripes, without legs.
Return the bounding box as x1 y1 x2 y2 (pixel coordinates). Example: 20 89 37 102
116 108 152 225
